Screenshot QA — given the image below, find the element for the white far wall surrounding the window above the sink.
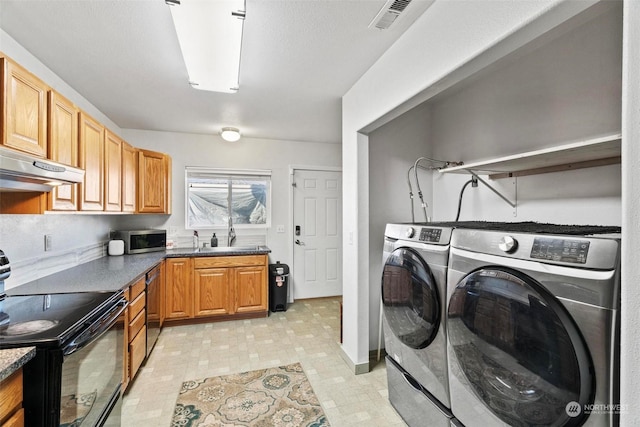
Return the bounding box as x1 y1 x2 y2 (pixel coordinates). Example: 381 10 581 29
122 129 341 265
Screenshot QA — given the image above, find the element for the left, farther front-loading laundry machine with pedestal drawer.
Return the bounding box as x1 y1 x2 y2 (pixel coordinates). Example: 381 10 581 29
381 223 453 427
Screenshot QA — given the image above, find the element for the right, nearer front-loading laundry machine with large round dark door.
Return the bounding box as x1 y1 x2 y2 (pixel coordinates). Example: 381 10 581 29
447 223 620 427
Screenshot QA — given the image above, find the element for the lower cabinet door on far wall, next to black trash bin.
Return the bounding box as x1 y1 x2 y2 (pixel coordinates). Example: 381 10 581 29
233 267 268 313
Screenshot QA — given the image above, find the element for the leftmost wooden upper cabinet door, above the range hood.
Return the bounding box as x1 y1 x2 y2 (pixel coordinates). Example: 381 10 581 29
0 58 48 157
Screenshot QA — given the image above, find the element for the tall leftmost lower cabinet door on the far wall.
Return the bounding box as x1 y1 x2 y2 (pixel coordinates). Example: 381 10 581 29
164 258 193 319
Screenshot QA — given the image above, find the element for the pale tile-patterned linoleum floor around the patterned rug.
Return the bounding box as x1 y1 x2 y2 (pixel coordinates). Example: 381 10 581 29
122 298 405 427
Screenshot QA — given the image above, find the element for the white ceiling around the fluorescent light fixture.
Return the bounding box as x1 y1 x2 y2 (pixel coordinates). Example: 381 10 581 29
0 0 432 142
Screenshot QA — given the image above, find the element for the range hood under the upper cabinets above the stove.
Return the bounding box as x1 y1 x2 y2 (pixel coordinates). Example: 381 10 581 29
0 146 84 191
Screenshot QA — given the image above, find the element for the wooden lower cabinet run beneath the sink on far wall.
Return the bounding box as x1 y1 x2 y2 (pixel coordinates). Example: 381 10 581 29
165 255 269 321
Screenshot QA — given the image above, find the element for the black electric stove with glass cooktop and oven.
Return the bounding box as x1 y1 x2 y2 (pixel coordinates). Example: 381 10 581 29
0 250 127 427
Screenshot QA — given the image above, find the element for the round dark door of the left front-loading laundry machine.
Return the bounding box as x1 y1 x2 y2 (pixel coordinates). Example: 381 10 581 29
382 248 441 349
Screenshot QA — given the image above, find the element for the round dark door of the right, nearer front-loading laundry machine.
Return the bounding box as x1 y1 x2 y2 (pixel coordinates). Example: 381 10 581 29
447 267 595 426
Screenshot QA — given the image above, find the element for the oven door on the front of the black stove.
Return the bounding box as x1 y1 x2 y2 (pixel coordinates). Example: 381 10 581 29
60 299 127 427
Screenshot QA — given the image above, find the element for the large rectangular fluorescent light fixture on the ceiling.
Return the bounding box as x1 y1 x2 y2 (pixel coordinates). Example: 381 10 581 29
167 0 245 93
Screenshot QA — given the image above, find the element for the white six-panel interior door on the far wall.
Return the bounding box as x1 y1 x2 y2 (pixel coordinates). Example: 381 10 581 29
292 169 342 299
